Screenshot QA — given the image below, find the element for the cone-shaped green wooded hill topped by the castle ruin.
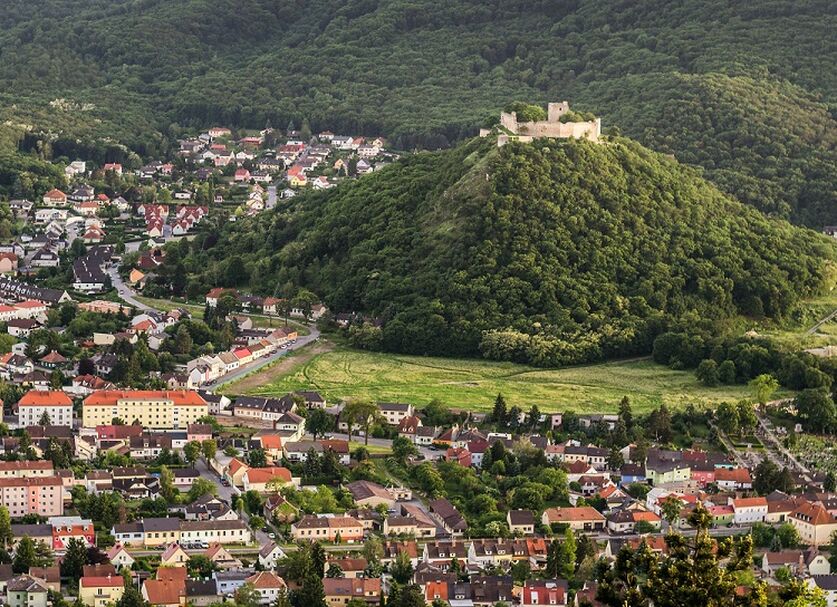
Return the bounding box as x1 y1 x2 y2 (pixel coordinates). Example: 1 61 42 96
167 138 837 365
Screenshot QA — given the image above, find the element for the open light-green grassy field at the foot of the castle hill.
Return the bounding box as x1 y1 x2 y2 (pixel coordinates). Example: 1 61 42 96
243 349 764 413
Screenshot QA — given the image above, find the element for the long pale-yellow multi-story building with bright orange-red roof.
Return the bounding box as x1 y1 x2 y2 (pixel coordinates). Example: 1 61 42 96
82 390 209 430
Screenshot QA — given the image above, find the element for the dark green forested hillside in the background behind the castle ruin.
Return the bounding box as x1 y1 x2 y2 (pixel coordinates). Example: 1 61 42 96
0 0 837 226
